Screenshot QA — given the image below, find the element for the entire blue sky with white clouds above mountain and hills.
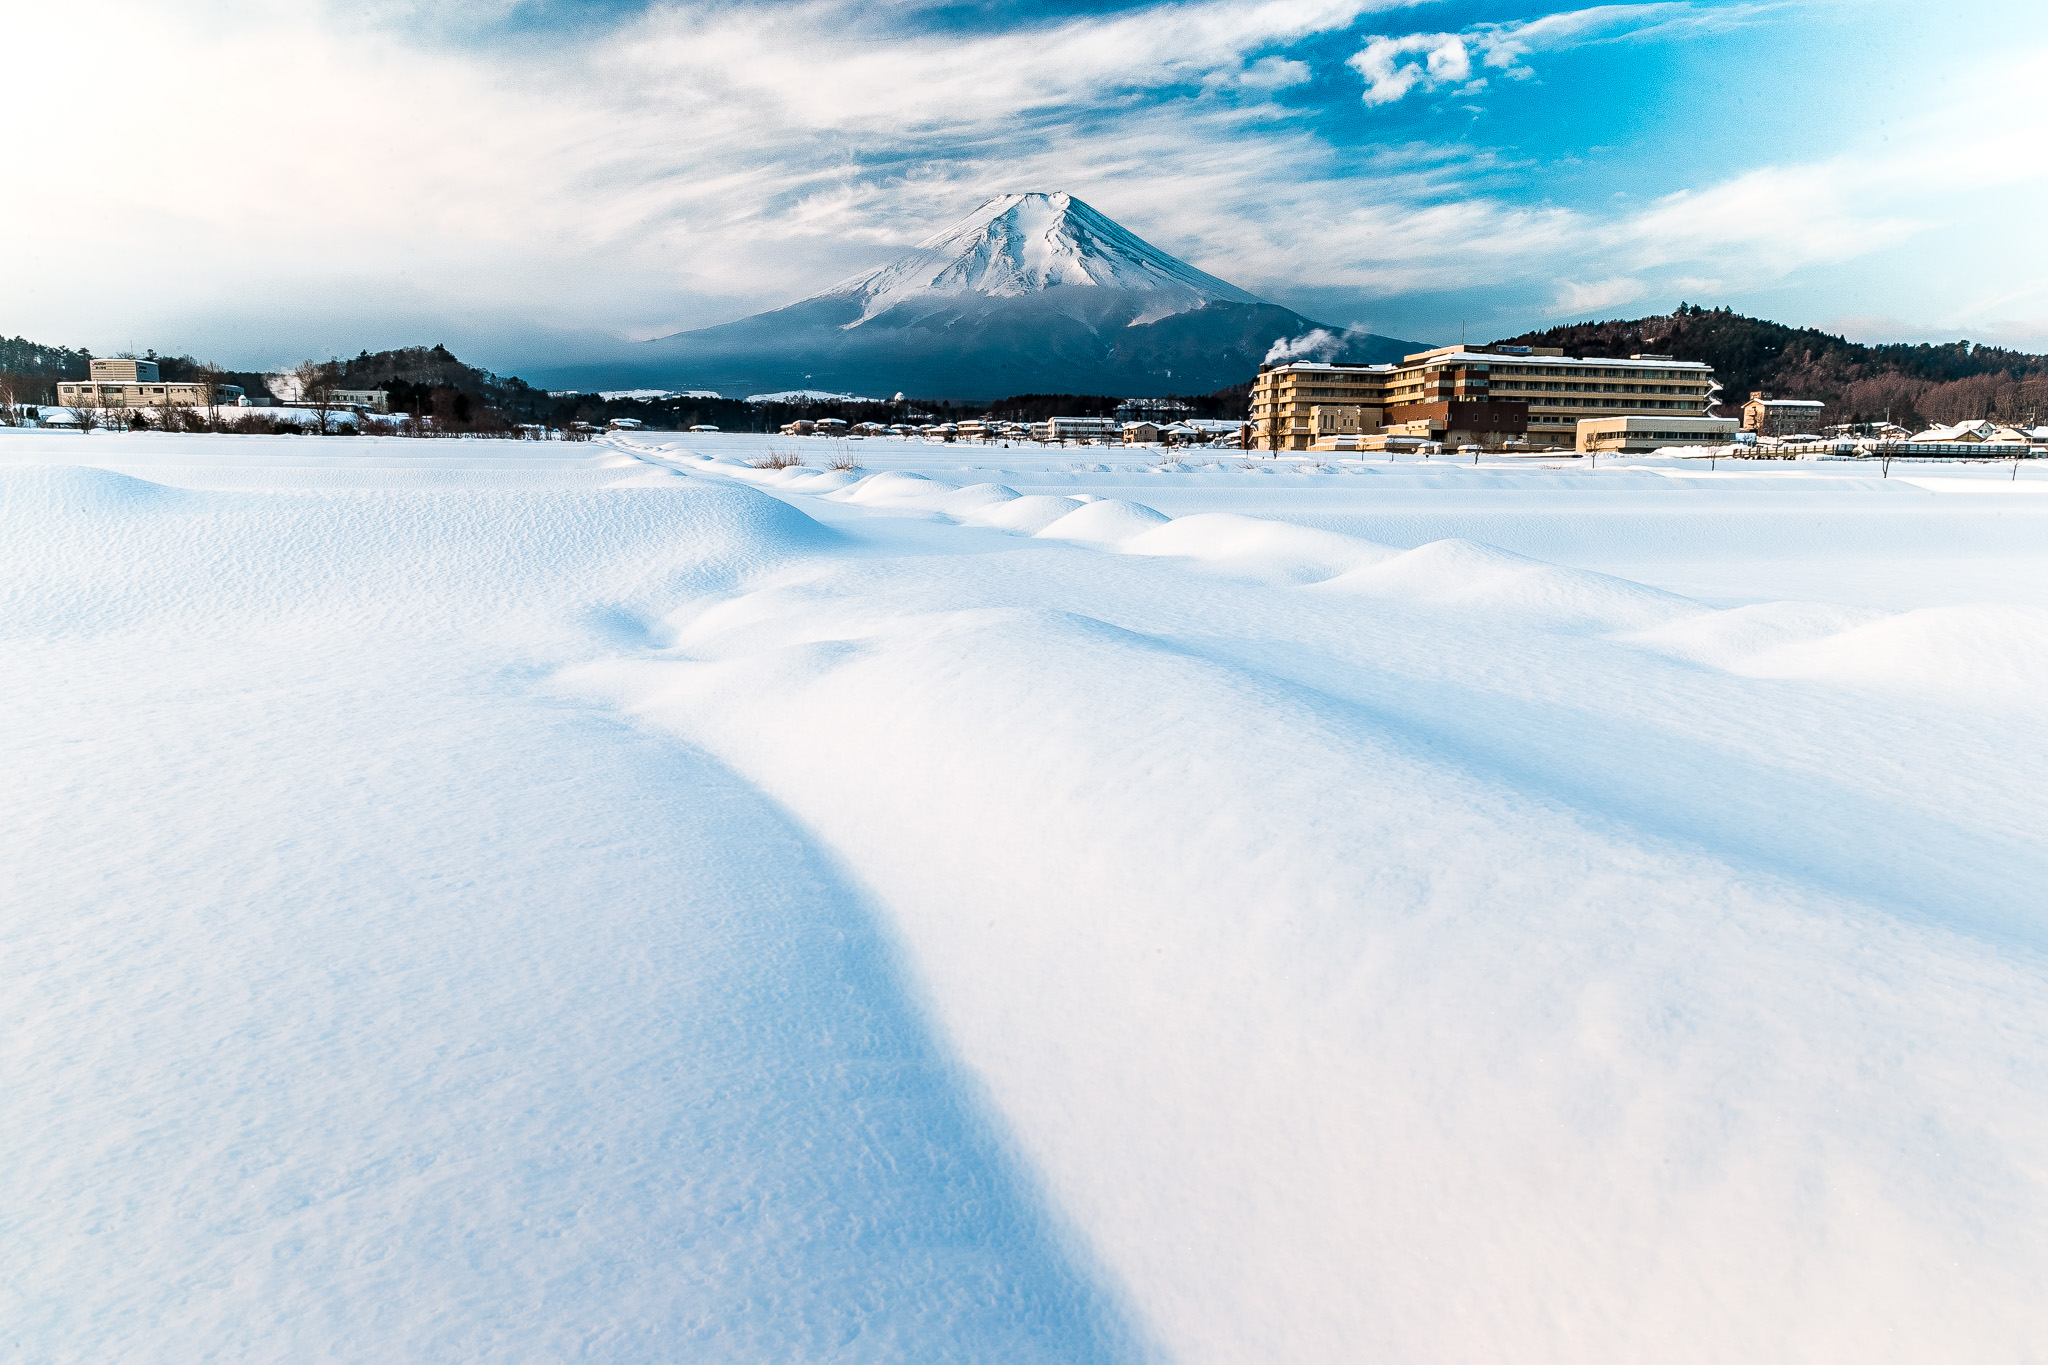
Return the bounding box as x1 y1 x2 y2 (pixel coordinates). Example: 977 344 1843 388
0 0 2048 368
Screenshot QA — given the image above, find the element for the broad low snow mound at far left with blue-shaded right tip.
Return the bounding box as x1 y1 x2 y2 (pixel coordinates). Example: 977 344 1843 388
0 469 838 634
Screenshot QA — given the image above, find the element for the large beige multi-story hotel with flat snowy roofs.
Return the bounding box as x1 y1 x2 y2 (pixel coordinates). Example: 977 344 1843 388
1251 346 1718 450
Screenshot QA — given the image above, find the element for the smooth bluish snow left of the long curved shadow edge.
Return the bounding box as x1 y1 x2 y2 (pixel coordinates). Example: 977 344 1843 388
0 456 1133 1361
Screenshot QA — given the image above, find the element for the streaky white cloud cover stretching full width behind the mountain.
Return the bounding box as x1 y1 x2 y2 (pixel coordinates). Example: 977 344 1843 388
0 0 2044 364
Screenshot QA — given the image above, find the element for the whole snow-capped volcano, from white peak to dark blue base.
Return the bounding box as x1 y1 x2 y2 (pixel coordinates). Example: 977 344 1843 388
547 194 1421 399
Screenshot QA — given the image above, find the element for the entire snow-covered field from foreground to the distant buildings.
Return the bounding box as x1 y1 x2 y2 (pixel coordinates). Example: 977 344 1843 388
0 432 2048 1363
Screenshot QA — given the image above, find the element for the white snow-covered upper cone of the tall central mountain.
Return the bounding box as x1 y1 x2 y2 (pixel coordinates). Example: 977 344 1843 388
831 194 1262 327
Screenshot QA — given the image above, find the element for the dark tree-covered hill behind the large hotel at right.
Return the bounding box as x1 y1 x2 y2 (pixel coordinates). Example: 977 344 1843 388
1501 303 2048 426
